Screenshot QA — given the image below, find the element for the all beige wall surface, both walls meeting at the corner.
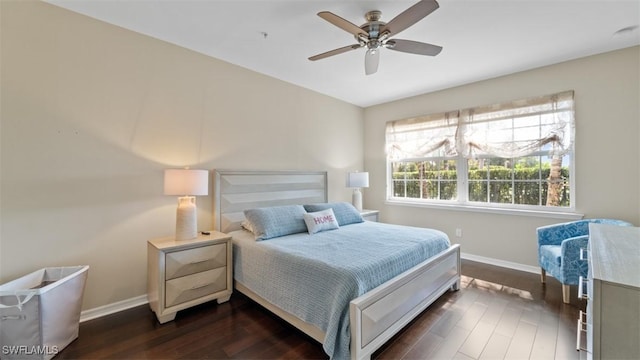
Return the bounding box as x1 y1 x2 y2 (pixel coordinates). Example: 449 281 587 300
0 1 640 309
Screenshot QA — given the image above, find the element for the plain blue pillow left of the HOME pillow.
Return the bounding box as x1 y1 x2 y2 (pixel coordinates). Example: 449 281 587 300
244 205 307 241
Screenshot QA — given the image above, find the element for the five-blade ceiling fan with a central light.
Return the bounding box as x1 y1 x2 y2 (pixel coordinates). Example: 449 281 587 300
309 0 442 75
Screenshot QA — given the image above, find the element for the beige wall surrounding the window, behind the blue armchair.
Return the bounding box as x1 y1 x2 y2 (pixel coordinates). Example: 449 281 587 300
364 47 640 266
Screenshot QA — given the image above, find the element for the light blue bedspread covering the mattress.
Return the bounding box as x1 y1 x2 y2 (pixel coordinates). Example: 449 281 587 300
233 221 450 359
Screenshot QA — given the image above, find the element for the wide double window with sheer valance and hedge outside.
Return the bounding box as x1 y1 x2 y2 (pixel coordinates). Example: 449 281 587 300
386 91 575 210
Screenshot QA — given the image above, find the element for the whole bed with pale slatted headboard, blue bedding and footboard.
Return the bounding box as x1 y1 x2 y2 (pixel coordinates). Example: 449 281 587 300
214 170 460 359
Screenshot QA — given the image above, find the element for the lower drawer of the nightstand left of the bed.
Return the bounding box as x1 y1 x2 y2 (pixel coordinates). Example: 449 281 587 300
165 267 227 307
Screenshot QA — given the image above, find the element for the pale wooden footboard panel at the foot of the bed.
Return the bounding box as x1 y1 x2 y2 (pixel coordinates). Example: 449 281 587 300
349 245 460 360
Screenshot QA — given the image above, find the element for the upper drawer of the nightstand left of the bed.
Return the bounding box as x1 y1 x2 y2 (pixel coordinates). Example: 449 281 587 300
165 244 227 280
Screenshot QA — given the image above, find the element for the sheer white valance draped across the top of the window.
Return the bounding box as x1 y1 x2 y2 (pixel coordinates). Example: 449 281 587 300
386 91 575 161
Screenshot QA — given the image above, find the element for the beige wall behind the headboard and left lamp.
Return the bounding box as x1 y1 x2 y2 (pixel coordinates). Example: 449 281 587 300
0 1 363 309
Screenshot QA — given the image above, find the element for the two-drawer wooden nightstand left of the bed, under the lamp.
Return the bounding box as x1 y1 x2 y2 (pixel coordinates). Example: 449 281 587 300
147 231 233 324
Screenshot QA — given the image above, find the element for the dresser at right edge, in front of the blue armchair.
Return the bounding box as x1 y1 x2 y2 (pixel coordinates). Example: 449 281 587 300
578 224 640 360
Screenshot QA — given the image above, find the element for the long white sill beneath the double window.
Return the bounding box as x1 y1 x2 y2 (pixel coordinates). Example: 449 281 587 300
385 199 584 220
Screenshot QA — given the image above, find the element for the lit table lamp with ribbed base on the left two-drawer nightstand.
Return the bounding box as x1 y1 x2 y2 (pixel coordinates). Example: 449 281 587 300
164 169 209 241
